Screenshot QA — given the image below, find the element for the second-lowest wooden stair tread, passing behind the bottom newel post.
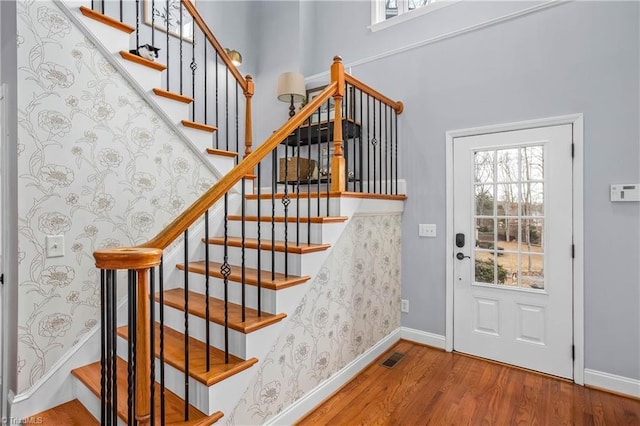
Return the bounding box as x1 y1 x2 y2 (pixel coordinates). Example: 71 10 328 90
71 358 222 426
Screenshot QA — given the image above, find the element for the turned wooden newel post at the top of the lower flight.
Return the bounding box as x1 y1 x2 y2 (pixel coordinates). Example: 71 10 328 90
331 56 346 192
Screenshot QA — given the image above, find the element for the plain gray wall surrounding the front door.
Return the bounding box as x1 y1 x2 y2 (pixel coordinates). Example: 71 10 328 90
303 2 640 379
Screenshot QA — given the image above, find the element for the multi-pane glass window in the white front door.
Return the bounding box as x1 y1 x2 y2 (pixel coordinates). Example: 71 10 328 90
474 145 545 290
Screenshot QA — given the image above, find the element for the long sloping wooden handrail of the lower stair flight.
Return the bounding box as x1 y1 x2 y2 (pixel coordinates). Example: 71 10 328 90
138 82 337 250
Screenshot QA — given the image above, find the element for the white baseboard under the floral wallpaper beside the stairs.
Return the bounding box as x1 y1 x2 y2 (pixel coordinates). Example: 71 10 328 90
265 328 400 426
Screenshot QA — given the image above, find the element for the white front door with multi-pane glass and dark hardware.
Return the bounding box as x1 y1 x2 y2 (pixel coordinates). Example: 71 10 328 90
453 125 573 378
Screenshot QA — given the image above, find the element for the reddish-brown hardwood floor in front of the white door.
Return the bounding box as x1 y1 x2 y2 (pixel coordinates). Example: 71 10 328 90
297 341 640 426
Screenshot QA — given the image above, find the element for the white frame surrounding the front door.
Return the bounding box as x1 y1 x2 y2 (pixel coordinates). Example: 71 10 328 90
445 113 584 385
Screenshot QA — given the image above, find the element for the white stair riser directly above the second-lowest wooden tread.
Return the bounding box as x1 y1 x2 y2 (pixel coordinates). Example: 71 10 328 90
116 336 262 416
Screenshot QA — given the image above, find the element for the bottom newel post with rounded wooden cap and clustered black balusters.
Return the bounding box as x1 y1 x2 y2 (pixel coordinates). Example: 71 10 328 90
93 247 162 425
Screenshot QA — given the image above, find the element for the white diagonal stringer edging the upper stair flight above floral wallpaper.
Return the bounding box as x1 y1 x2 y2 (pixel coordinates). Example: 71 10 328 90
52 0 230 181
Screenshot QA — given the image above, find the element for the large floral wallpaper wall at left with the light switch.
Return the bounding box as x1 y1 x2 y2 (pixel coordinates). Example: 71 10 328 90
18 0 214 391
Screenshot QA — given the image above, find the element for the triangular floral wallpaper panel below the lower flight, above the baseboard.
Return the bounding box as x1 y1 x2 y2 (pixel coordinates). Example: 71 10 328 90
222 215 401 426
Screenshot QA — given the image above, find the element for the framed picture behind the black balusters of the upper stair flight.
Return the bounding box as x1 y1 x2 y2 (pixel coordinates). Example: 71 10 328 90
144 0 195 43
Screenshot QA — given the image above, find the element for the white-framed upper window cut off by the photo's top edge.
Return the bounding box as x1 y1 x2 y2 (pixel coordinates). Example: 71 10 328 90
370 0 457 31
